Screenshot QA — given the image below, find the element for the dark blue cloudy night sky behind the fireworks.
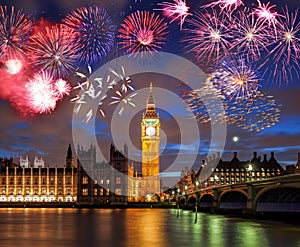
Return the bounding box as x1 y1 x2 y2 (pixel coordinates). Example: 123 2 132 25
0 0 300 173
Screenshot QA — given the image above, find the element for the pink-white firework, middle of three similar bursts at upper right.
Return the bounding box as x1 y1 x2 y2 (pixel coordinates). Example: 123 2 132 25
231 10 272 60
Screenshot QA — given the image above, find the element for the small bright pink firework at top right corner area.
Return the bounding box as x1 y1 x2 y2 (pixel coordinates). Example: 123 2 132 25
254 0 278 30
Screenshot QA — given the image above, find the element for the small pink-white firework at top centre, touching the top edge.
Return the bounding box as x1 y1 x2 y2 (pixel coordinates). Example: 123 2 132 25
158 0 191 30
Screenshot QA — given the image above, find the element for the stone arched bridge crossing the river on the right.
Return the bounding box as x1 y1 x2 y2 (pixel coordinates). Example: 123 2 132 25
178 174 300 215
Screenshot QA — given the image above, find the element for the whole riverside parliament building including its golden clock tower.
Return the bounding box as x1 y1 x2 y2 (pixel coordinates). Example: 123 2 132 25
0 84 160 205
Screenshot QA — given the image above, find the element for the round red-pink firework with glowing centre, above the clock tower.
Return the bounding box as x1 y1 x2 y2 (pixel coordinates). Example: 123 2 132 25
118 11 168 55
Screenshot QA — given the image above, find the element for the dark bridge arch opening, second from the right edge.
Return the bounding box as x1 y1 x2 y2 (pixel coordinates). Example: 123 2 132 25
218 190 248 209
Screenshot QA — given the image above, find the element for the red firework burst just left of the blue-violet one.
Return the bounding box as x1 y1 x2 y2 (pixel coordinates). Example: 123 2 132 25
28 25 77 78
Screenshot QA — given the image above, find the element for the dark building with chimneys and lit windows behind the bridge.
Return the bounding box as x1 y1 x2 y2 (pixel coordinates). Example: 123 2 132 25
176 152 285 193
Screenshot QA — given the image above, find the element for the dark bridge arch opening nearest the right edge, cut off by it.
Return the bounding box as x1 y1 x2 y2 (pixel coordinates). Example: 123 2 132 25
254 186 300 212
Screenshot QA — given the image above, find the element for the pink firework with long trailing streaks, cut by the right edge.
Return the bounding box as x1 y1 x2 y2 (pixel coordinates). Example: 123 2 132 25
262 7 300 84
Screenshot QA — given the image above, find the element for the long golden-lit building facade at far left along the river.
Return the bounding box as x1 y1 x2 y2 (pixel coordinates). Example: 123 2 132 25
0 146 77 202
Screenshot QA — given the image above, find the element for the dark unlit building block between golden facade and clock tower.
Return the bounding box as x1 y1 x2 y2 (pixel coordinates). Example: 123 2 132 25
77 145 128 205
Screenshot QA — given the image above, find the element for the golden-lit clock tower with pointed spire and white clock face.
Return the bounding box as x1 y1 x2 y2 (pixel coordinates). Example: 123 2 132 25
141 83 160 195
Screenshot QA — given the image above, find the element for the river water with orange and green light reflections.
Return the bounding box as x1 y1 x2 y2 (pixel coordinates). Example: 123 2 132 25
0 208 300 247
